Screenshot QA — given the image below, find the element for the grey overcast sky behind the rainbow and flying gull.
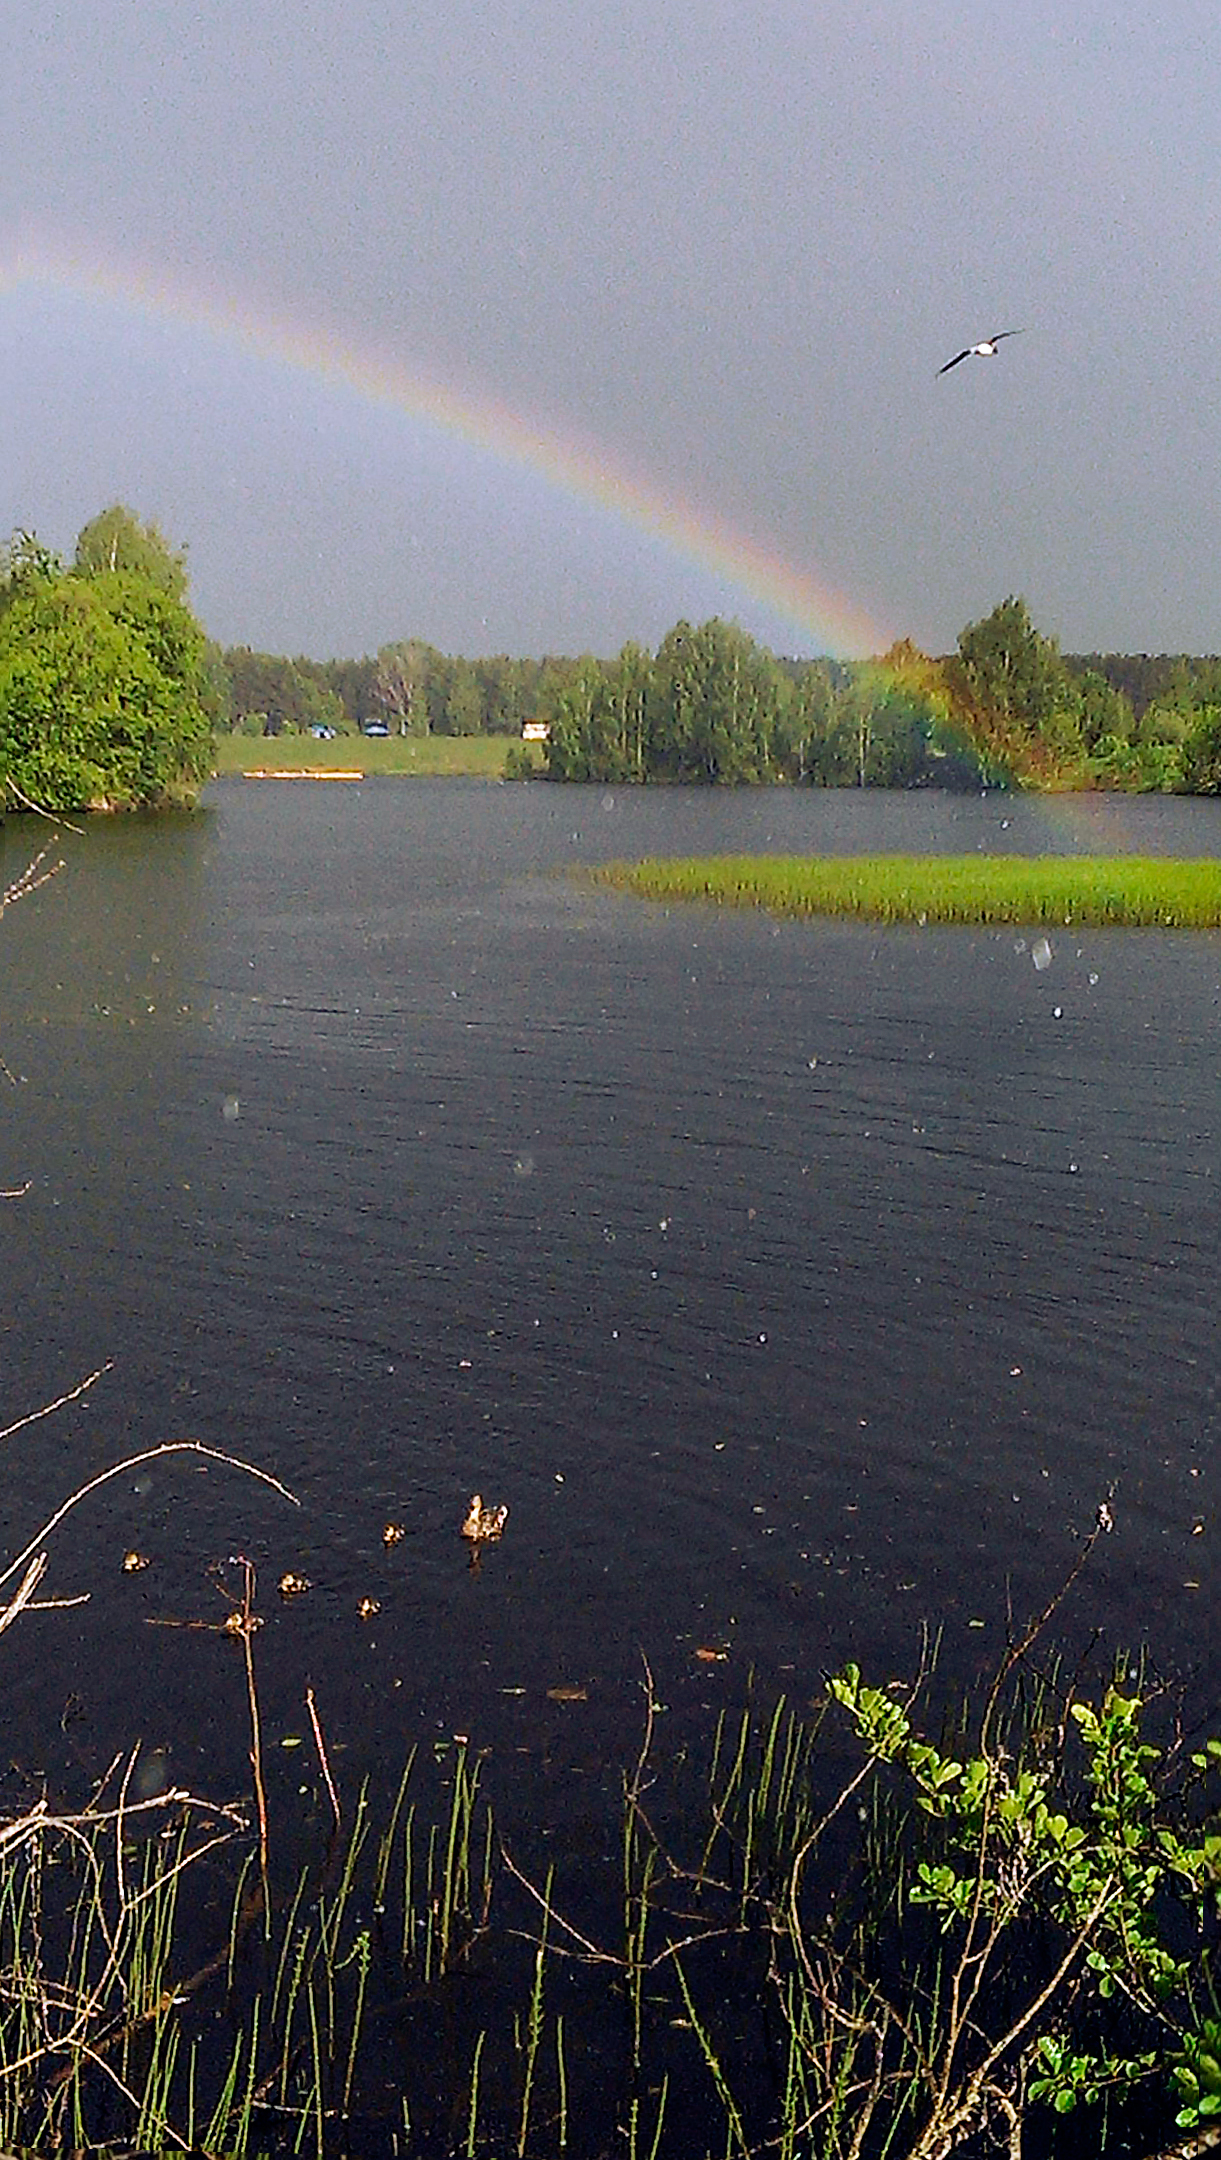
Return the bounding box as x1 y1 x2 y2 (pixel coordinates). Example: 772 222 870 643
0 0 1221 654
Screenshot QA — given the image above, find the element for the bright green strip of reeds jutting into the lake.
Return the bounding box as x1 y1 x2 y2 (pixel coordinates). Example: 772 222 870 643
588 855 1221 929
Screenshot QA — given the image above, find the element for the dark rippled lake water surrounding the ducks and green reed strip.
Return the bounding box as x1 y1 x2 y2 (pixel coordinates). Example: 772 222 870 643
0 780 1221 1814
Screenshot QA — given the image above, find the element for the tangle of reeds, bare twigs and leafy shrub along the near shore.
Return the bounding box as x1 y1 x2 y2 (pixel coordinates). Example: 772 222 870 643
0 1615 1221 2160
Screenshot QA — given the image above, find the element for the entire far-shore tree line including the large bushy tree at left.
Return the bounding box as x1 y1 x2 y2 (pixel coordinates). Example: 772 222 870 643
0 503 1221 808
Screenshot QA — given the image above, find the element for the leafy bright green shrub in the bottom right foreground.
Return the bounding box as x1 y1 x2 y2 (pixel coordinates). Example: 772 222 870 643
830 1665 1221 2149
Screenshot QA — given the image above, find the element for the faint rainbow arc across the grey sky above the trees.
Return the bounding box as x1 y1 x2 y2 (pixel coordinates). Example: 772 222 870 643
0 240 893 659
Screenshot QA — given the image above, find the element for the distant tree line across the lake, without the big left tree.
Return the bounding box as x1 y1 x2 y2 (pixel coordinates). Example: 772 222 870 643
216 598 1221 793
